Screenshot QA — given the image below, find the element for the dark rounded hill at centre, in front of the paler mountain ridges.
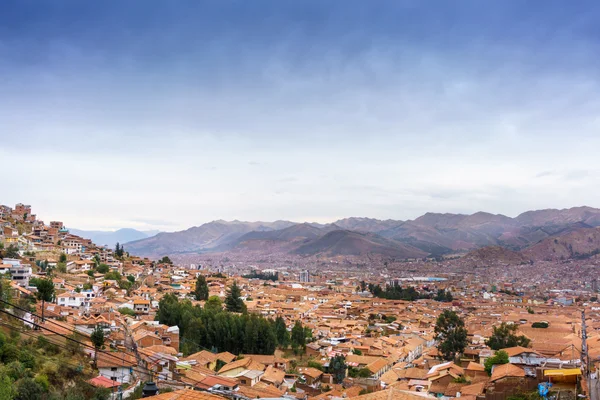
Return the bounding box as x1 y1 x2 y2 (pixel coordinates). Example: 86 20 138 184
294 230 427 258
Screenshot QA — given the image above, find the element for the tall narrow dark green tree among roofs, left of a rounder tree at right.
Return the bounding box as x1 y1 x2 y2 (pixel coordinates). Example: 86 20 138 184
434 310 467 361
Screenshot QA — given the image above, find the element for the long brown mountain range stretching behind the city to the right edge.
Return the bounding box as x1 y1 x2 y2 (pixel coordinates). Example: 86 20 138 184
125 207 600 259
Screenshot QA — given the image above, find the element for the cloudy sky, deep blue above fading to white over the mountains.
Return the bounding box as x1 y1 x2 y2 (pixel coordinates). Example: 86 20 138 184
0 0 600 231
